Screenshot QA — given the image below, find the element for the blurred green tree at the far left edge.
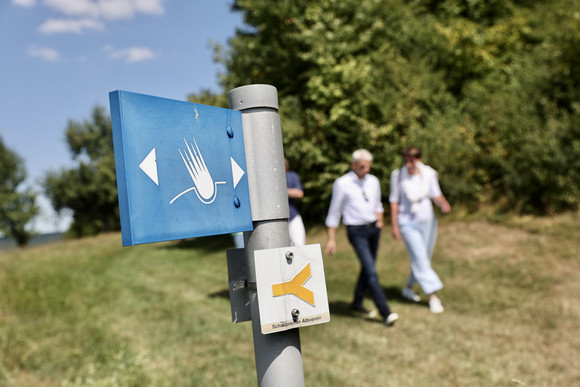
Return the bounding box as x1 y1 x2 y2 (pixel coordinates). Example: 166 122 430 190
0 138 38 246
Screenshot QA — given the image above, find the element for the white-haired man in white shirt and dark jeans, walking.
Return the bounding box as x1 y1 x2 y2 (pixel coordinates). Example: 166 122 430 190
325 149 399 326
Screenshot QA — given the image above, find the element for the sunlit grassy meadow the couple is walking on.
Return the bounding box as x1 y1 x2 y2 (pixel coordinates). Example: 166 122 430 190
0 214 580 387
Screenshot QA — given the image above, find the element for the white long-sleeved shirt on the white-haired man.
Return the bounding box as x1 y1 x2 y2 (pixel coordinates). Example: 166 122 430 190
326 171 385 228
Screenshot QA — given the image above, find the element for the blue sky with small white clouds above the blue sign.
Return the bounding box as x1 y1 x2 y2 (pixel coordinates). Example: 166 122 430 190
0 0 242 232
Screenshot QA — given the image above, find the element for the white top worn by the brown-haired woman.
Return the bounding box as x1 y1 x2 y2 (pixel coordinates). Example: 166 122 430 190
389 164 441 222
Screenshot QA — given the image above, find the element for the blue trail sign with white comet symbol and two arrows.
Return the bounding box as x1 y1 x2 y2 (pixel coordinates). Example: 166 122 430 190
109 90 252 246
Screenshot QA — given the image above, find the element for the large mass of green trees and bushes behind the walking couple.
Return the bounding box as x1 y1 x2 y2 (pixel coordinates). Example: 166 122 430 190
201 0 580 220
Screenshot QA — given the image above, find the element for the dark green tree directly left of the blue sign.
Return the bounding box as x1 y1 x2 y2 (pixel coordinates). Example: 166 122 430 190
43 107 120 236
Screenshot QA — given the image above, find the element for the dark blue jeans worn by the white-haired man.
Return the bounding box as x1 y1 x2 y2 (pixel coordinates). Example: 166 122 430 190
346 224 391 317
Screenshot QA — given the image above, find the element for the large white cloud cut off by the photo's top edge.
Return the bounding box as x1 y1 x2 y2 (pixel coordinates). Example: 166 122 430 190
42 0 166 20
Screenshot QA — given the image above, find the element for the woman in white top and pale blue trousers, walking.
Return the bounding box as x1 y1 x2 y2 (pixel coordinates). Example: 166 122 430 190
389 146 451 313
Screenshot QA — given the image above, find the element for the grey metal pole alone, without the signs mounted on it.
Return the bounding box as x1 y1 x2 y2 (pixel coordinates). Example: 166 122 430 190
229 85 304 387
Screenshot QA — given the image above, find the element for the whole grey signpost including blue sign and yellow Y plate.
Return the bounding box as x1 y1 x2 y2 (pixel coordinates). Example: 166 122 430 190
110 85 330 387
